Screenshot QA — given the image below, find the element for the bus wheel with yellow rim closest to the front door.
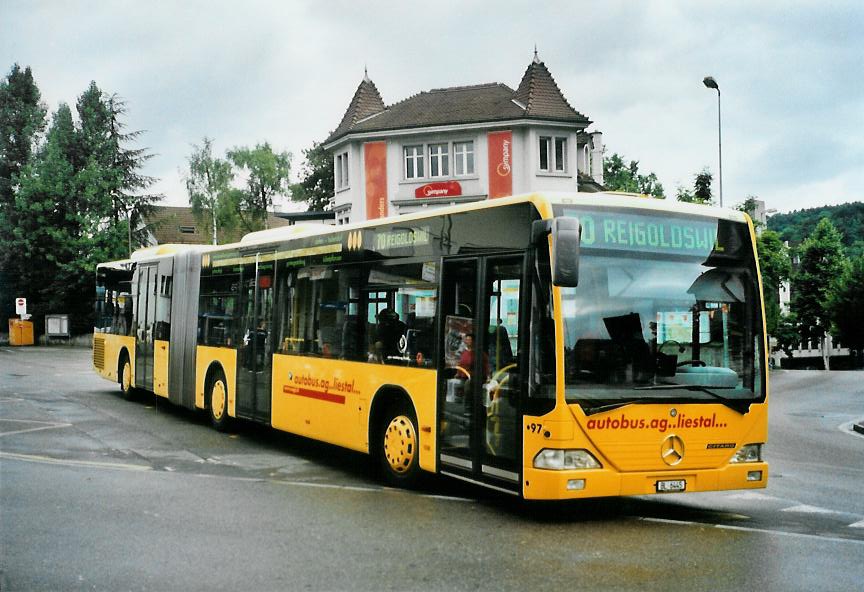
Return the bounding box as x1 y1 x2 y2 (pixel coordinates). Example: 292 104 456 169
377 402 420 488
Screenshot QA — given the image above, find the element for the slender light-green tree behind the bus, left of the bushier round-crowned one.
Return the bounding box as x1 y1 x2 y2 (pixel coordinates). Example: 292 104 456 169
186 137 238 245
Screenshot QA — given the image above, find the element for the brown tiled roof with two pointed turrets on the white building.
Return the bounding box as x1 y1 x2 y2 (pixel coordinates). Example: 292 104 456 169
325 59 591 144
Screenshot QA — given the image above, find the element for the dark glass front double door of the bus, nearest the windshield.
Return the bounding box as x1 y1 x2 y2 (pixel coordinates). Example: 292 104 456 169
438 255 527 492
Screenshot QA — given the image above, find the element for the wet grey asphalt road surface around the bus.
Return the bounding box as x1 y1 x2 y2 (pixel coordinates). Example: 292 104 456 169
0 347 864 592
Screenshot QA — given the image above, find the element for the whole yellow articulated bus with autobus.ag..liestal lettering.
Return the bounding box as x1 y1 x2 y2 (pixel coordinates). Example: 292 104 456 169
93 193 768 499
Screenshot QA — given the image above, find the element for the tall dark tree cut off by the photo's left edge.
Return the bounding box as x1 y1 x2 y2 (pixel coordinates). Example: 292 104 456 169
0 64 47 323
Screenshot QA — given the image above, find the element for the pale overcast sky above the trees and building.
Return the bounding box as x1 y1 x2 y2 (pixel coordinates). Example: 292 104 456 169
0 0 864 211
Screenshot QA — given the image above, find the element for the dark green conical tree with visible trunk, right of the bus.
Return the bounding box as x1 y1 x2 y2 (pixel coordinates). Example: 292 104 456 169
792 218 845 370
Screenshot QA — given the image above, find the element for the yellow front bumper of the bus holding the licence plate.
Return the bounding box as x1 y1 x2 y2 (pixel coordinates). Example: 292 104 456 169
522 462 768 500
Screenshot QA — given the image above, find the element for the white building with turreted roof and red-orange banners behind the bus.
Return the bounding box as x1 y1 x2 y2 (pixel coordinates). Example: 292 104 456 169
325 55 603 223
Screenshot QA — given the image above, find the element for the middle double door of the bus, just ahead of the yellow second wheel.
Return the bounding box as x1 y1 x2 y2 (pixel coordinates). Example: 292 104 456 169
237 252 276 420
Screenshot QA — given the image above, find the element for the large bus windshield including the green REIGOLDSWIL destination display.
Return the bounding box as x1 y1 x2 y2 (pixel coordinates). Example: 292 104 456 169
561 208 764 413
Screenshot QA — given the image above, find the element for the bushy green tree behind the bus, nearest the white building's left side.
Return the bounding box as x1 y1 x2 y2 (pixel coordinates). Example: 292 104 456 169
227 142 291 231
